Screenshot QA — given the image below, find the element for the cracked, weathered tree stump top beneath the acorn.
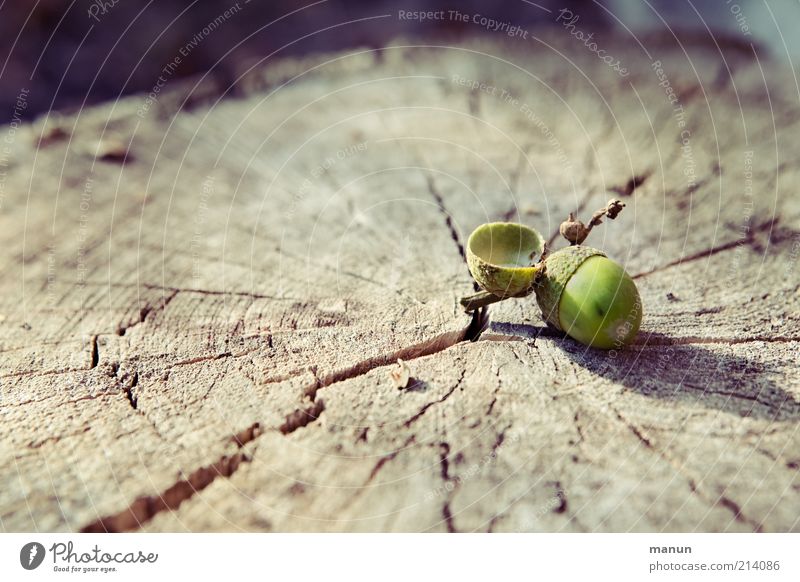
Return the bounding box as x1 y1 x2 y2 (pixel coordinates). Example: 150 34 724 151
0 31 800 531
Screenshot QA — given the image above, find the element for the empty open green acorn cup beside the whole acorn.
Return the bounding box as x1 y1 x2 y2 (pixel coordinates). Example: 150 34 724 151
466 222 544 297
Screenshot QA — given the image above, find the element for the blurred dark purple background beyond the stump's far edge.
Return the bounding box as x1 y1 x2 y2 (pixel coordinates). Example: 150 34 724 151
0 0 800 123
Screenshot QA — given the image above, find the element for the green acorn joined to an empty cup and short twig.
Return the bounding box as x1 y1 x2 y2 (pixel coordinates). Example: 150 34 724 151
461 200 642 349
